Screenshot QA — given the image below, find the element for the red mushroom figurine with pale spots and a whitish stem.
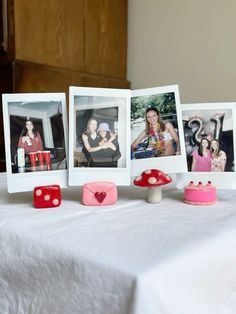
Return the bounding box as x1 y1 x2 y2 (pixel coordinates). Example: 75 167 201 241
134 169 172 203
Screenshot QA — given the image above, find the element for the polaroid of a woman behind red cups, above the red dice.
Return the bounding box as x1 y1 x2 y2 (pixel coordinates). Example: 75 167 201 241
2 93 67 193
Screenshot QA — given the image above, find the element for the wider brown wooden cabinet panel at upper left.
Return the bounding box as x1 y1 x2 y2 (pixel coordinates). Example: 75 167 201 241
14 0 84 71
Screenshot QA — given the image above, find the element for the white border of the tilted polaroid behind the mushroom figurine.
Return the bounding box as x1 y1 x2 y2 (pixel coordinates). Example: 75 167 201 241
131 85 187 176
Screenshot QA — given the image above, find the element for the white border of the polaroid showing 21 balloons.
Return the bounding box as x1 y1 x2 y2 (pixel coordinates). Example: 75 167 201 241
176 102 236 189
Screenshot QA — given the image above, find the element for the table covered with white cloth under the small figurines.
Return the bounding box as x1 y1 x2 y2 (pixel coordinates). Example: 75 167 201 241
0 174 236 314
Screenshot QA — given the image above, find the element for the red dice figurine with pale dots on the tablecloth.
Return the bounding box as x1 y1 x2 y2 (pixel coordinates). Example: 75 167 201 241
33 184 61 208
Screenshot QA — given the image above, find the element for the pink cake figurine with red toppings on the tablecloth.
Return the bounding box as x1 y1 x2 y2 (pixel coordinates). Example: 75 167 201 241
184 181 216 205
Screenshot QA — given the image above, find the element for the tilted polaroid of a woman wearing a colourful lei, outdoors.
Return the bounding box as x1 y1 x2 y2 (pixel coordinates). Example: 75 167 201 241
131 85 187 176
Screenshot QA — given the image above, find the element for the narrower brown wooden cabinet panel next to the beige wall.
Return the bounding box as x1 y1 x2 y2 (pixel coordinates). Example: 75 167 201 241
85 0 127 79
